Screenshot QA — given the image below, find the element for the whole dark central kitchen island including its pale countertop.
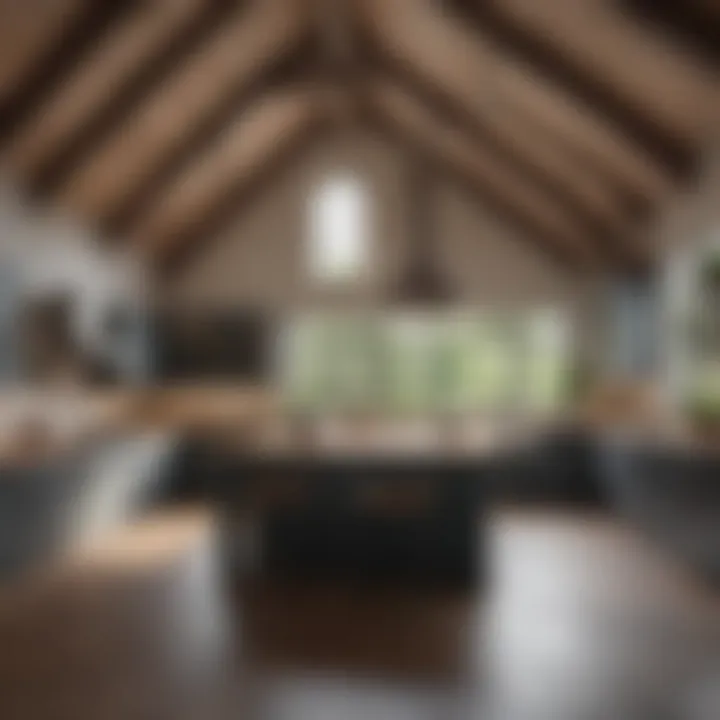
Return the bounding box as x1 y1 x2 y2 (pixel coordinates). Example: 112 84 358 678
197 426 564 586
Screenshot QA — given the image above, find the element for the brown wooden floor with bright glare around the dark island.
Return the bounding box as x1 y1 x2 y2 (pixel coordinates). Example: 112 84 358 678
0 512 720 720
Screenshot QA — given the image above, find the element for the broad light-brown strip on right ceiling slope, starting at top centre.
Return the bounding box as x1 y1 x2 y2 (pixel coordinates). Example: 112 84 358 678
362 0 672 207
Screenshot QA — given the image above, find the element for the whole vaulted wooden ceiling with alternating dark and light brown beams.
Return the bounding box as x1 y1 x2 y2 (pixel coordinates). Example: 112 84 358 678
0 0 720 271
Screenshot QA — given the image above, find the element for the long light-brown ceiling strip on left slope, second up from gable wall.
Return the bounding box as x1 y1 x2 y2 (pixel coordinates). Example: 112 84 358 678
57 0 316 225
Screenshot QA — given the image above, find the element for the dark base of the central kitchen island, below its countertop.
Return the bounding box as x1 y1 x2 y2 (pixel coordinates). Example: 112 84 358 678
205 455 491 585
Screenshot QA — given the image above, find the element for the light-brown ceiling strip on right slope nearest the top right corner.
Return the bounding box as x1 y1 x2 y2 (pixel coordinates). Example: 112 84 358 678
462 0 718 154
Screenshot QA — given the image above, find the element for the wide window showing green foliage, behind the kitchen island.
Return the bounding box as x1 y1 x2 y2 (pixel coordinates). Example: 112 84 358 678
281 310 570 413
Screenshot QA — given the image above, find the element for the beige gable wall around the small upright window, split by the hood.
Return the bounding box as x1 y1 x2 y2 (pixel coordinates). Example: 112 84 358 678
168 134 584 316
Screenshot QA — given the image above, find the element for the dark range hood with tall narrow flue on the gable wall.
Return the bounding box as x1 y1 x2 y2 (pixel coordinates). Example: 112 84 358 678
392 158 453 307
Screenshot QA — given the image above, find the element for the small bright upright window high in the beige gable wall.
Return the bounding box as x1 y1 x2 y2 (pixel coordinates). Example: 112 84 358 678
307 174 369 283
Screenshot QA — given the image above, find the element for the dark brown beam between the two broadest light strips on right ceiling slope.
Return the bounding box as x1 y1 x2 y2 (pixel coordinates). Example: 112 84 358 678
452 0 696 179
